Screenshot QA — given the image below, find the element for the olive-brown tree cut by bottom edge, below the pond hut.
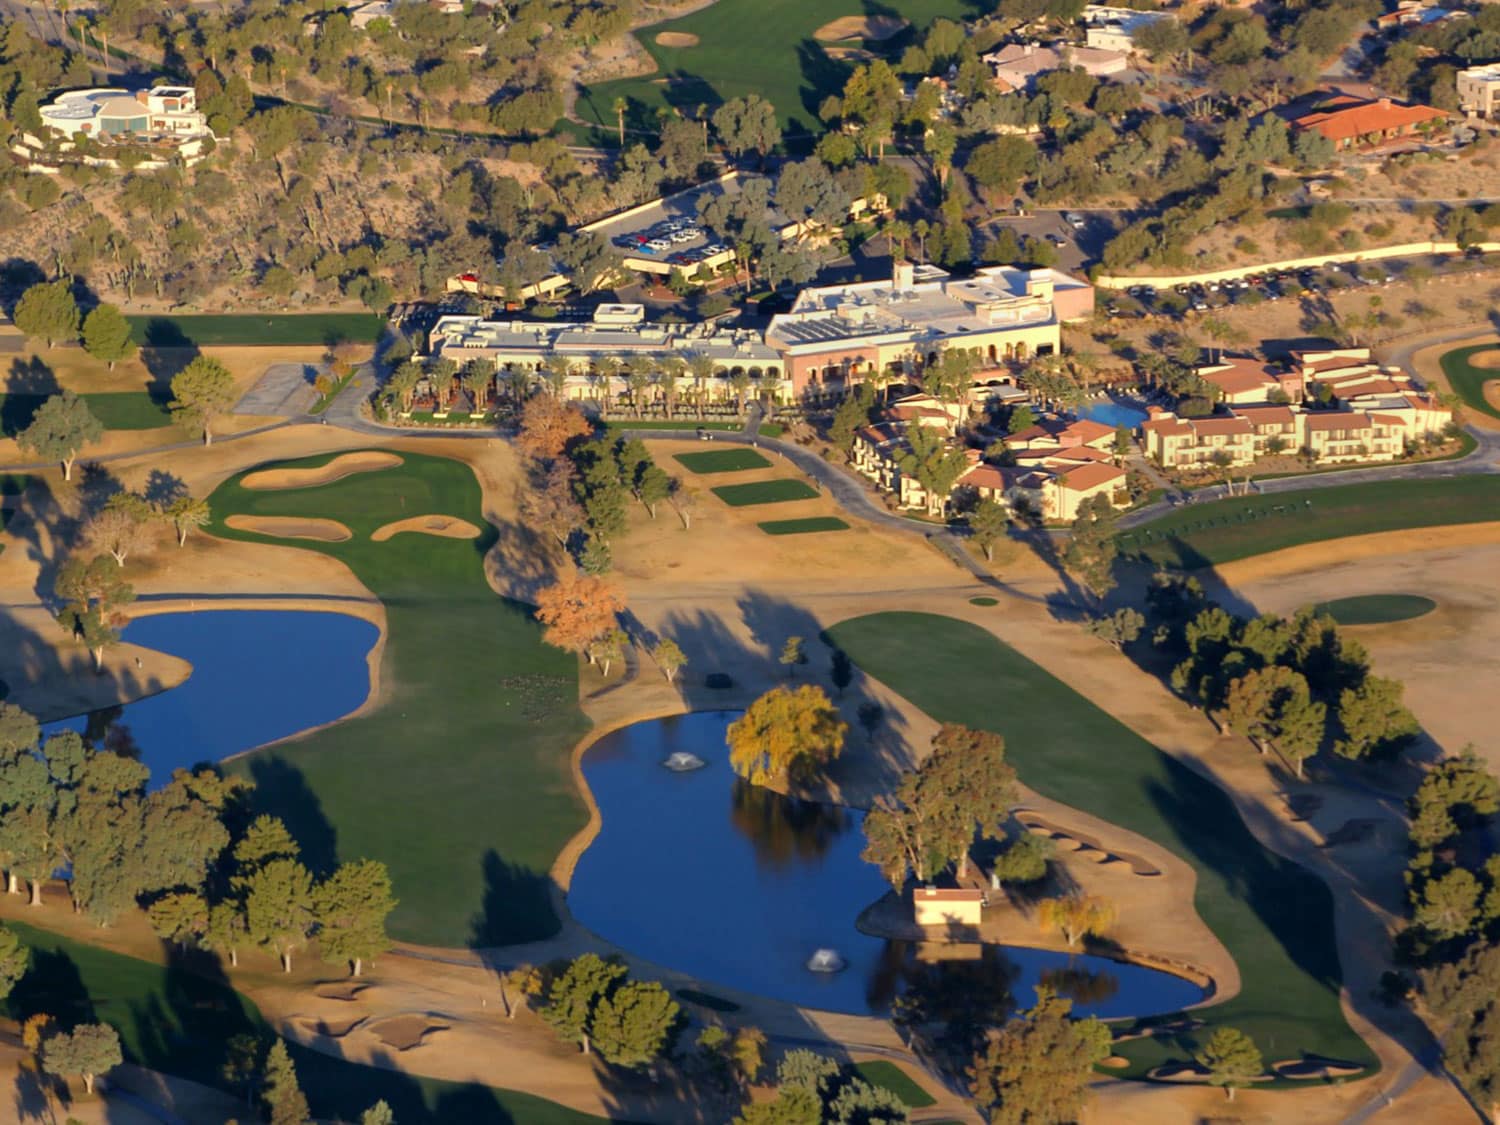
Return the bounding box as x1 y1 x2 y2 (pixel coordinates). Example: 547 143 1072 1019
969 986 1113 1125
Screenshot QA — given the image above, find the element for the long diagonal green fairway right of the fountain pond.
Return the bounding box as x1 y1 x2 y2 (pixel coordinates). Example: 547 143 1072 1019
828 614 1377 1077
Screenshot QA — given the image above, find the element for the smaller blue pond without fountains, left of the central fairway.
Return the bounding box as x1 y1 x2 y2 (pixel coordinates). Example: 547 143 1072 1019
48 609 380 785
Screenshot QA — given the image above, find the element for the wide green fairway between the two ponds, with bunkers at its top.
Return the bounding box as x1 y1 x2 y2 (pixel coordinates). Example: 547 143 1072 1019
210 452 588 947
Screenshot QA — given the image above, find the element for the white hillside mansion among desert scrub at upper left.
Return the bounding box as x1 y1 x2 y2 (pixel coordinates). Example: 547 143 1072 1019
12 86 215 173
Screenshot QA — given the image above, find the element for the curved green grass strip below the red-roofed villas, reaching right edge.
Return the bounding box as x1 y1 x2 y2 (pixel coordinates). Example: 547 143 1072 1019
1119 474 1500 569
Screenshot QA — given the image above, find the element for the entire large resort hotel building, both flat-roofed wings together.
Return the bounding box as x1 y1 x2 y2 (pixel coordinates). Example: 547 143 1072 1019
429 264 1094 402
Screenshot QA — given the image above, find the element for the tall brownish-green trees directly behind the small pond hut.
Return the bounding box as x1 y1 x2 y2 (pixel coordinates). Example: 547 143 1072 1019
863 723 1016 891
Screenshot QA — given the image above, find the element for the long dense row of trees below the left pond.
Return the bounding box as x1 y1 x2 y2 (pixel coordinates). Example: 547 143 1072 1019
0 704 396 974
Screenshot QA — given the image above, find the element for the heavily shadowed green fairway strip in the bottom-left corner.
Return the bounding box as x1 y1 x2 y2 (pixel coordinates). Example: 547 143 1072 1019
6 921 603 1125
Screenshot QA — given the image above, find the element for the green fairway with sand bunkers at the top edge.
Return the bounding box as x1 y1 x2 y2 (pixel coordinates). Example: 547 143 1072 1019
578 0 989 143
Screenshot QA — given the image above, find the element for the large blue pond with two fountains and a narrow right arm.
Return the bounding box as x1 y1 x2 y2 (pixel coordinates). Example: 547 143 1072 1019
569 711 1203 1017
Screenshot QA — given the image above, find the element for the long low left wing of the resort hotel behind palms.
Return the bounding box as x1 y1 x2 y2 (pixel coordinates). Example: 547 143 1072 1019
429 305 792 405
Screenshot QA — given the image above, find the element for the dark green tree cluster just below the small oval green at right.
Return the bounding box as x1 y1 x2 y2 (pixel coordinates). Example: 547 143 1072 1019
1148 575 1419 777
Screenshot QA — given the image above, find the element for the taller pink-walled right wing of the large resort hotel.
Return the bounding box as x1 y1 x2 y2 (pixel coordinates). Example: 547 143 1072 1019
765 263 1094 396
